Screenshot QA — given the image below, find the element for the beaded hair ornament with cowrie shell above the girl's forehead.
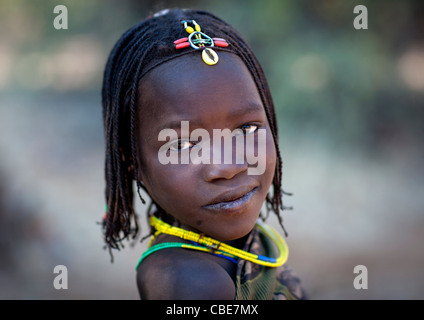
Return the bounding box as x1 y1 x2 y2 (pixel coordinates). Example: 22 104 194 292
174 20 228 66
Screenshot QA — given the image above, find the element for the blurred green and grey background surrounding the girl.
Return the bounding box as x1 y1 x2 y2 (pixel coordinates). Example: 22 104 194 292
0 0 424 299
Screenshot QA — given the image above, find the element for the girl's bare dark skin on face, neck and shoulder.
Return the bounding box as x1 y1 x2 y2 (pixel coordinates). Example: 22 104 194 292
137 52 276 299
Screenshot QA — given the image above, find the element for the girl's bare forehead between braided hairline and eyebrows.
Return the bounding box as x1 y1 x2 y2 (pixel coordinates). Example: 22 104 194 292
139 52 262 118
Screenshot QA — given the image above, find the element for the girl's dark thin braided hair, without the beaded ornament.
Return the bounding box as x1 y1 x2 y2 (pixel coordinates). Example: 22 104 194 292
102 9 287 255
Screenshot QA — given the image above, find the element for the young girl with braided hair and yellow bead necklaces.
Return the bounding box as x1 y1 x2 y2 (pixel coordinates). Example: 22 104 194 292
102 9 304 300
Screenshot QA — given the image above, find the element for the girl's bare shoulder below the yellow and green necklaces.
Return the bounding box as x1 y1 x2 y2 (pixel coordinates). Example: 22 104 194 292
137 248 235 300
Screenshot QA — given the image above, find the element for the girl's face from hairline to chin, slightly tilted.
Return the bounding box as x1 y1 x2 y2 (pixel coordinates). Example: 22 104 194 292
137 52 276 241
